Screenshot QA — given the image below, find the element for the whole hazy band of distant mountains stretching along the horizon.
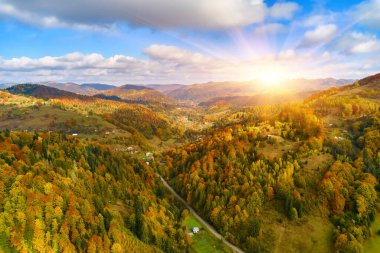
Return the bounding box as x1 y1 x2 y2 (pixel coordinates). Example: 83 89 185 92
1 78 353 106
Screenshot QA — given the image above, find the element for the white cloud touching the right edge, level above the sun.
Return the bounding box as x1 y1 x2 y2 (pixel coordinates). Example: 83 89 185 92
335 32 380 55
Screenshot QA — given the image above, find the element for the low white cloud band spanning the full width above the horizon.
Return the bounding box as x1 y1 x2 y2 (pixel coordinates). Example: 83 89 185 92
0 44 380 84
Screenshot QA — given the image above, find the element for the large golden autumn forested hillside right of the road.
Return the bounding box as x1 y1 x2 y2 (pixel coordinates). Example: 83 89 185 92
159 75 380 252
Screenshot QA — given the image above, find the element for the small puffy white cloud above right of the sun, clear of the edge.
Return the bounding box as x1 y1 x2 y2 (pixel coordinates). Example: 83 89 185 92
299 24 337 47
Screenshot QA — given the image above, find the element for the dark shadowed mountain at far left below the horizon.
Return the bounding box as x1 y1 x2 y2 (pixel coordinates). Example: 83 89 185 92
6 84 91 100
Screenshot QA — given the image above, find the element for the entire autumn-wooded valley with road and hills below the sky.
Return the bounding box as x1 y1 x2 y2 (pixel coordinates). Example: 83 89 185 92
0 74 380 252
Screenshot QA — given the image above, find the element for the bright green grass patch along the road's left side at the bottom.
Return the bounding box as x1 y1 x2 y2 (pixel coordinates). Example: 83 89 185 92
182 214 232 253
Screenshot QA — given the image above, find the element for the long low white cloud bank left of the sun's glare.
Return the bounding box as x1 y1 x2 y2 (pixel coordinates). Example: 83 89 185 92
0 45 240 84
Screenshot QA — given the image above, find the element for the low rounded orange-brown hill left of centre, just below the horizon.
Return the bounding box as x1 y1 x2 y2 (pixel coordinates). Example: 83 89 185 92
95 84 175 104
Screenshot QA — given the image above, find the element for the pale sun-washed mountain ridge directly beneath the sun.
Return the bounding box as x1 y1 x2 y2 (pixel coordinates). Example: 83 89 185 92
168 78 353 102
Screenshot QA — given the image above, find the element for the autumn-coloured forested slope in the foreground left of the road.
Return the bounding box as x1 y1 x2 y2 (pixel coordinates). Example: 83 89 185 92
0 131 190 252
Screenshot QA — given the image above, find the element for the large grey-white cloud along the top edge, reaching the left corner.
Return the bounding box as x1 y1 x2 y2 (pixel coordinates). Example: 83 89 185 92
0 0 266 29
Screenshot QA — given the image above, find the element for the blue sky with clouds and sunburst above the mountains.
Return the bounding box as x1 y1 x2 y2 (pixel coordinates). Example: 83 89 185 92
0 0 380 85
